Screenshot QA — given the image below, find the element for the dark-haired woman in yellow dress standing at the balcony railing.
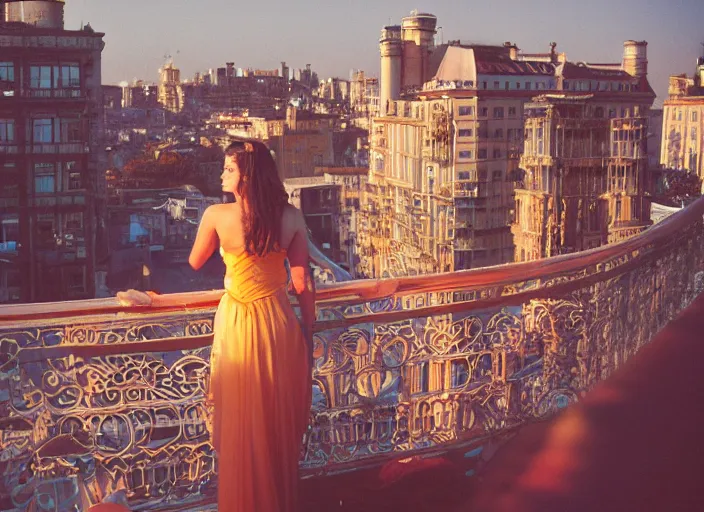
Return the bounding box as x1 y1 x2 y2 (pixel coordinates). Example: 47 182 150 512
188 141 315 512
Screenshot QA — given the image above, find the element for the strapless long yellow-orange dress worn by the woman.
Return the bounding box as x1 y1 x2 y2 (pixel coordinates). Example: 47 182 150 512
208 249 312 512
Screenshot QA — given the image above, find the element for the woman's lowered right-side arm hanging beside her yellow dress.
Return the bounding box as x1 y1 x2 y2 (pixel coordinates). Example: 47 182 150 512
288 210 315 355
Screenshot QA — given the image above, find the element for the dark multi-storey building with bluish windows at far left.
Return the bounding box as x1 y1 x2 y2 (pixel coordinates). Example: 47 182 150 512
0 0 107 302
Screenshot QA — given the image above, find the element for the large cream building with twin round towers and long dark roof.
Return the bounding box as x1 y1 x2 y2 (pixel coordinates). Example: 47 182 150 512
365 12 652 277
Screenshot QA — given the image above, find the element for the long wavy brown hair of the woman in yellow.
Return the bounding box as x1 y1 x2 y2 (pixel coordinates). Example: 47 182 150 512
225 139 288 256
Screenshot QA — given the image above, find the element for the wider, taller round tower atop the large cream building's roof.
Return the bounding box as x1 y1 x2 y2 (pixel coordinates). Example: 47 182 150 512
401 11 438 88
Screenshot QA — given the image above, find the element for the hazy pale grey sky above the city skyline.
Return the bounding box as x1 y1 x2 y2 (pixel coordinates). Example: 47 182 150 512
66 0 704 104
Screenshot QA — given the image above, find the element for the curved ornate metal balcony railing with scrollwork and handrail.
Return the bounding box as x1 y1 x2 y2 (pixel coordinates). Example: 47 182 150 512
0 195 704 510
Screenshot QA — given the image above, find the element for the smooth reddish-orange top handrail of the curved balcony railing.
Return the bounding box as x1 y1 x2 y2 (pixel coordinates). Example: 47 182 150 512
0 197 704 322
